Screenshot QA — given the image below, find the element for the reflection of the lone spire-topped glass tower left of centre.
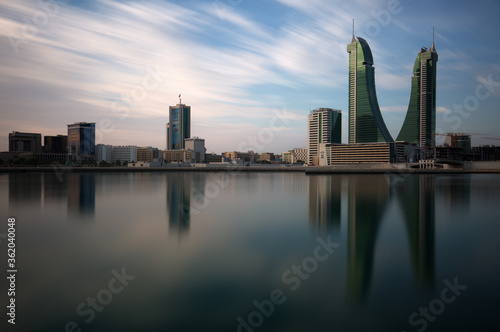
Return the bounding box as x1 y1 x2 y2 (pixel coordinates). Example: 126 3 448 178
166 172 206 237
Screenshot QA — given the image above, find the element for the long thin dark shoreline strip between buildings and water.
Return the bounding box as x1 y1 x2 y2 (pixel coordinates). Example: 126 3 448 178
0 166 500 175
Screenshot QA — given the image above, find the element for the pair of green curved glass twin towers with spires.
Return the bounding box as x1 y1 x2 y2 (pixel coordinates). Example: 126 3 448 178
347 31 438 147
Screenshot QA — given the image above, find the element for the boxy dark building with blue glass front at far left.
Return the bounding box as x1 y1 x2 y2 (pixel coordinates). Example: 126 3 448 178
68 122 95 156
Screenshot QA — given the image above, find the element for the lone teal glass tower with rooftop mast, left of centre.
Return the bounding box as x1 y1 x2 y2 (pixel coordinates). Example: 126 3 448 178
167 100 191 150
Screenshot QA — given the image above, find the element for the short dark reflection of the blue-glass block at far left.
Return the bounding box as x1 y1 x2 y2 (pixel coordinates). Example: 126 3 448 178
65 173 95 220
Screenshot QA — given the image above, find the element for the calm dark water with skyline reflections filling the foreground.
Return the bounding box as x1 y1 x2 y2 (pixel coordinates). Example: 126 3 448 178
0 173 500 332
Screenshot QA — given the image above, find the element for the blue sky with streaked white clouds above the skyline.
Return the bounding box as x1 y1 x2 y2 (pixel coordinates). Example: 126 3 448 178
0 0 500 153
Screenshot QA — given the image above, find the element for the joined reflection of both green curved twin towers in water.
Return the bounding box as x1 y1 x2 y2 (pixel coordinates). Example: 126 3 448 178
347 175 435 300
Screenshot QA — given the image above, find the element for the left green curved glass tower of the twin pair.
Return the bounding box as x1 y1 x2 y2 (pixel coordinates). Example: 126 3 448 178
347 34 394 144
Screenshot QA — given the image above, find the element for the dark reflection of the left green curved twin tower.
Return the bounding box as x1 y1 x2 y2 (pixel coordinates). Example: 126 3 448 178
347 175 390 300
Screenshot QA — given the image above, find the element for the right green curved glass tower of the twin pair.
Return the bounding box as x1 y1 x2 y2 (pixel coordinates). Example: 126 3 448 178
397 35 438 147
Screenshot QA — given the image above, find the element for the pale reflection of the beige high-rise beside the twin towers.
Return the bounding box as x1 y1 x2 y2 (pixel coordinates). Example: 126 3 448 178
307 175 342 233
